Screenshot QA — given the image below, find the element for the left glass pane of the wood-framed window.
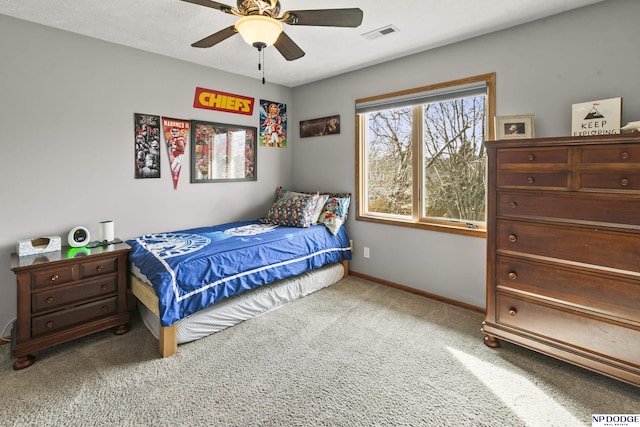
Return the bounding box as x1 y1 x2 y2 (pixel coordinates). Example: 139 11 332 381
365 106 413 217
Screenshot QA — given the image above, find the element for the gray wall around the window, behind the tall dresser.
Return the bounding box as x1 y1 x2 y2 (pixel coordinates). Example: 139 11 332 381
293 0 640 307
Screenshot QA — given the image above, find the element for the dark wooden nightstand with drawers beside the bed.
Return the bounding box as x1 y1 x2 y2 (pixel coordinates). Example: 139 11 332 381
11 243 131 370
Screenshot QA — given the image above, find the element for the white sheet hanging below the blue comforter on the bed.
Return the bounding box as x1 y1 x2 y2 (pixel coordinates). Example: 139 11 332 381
132 263 344 344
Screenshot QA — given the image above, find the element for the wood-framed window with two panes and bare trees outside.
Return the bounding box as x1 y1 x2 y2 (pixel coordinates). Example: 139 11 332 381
356 73 495 236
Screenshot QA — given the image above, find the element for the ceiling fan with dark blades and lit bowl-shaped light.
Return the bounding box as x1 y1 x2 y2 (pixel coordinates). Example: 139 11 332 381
182 0 362 61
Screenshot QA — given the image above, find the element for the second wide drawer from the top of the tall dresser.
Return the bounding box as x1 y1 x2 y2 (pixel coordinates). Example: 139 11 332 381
496 219 640 272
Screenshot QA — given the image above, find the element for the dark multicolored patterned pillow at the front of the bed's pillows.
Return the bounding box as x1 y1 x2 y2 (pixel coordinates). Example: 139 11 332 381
261 192 319 228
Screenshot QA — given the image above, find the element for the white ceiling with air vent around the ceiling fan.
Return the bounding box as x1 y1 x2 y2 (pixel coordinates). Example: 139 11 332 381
0 0 603 87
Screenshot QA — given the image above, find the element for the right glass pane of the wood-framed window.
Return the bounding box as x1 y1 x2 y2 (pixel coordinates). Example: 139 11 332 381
422 96 485 223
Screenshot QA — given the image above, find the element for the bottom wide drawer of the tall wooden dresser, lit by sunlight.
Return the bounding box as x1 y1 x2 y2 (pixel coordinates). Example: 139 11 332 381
496 292 640 367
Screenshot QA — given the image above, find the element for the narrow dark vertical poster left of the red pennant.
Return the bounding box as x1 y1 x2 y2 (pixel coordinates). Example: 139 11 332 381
134 113 160 179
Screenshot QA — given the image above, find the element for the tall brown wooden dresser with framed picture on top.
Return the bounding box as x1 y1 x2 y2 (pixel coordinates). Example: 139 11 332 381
482 134 640 386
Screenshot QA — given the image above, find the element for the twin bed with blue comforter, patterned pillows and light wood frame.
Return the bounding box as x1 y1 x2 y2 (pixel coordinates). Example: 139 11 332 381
127 188 351 357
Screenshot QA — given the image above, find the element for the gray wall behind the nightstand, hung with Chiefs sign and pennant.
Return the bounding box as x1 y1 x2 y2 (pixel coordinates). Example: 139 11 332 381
0 15 295 328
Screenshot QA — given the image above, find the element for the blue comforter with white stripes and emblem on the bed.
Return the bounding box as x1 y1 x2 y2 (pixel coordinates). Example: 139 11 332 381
127 220 351 326
